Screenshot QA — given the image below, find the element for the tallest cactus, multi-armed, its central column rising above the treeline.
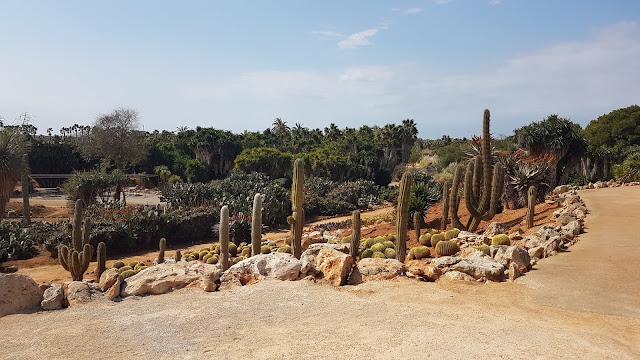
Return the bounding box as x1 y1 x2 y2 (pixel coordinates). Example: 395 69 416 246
451 110 505 231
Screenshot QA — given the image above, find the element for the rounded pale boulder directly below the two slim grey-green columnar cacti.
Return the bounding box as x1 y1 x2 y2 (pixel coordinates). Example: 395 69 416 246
220 253 301 288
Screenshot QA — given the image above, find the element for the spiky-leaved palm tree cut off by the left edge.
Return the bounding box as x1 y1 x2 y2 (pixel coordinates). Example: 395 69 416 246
0 129 29 220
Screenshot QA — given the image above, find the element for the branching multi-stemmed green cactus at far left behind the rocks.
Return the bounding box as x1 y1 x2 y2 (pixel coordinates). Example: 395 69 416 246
58 199 94 281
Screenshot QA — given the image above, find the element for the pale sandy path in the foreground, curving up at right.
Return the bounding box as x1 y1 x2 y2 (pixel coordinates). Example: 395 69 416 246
0 188 640 359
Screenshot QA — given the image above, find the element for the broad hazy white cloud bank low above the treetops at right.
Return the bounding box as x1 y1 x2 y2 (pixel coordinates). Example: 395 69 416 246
178 22 640 138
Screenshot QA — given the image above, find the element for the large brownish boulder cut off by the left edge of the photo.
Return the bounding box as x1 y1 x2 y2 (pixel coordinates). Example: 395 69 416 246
0 273 42 317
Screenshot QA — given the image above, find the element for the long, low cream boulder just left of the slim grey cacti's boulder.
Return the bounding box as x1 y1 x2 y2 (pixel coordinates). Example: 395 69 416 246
120 260 222 297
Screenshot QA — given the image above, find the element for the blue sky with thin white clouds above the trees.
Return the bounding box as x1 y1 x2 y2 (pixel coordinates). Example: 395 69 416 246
0 0 640 139
